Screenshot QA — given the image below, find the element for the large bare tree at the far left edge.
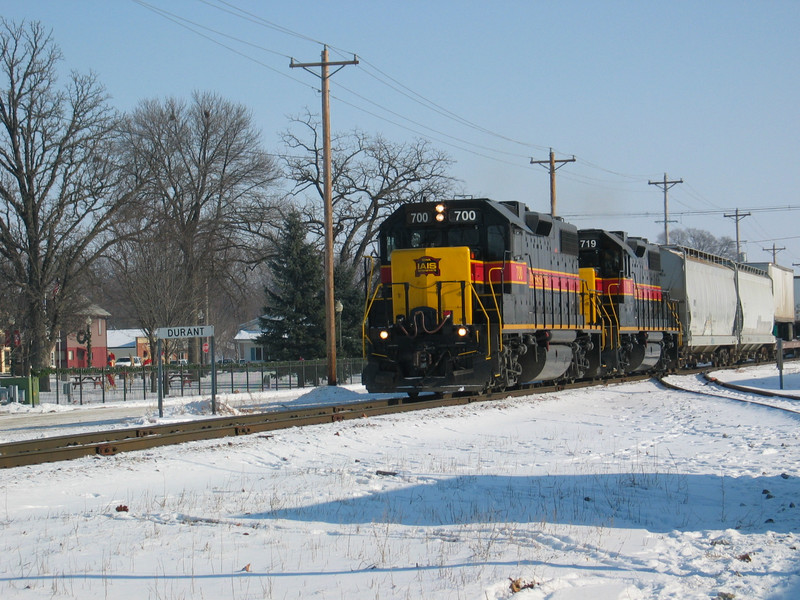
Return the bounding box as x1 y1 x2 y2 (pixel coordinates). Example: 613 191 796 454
0 19 135 378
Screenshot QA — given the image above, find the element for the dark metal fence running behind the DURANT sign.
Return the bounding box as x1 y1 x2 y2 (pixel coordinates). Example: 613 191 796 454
33 358 365 404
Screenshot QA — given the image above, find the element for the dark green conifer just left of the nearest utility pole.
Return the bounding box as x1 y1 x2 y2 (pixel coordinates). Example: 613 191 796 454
258 209 325 360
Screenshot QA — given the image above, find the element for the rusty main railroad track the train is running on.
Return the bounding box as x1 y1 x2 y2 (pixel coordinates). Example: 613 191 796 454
0 375 649 468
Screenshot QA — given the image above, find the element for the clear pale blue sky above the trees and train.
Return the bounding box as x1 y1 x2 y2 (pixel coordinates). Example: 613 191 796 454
0 0 800 272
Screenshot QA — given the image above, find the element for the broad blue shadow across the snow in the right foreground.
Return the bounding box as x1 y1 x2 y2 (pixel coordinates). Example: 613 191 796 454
244 472 800 533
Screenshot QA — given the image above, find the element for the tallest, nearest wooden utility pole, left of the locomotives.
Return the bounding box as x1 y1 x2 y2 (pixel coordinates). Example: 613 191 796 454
289 46 358 385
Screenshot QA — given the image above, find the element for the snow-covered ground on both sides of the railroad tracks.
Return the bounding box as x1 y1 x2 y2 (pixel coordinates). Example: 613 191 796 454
0 365 800 600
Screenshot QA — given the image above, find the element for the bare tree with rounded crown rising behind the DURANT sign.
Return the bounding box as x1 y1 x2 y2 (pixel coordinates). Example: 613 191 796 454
115 93 279 361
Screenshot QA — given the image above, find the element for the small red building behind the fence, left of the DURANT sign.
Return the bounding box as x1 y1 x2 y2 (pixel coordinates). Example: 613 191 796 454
53 304 111 369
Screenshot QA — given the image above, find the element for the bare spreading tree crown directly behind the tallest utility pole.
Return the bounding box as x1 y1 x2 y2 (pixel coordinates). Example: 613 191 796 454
282 113 455 265
